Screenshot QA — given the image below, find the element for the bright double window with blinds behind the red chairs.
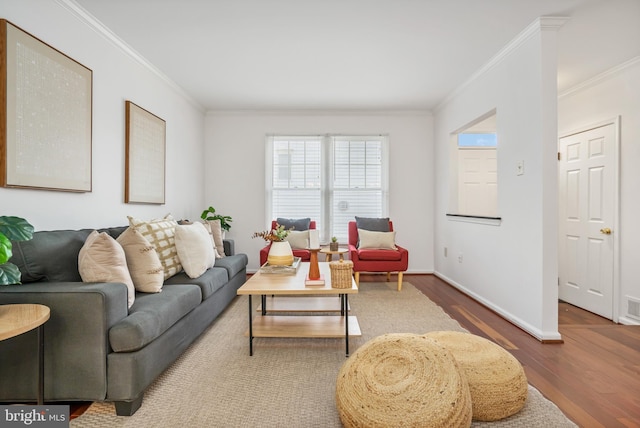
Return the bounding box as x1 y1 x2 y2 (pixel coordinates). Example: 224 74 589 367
266 135 388 242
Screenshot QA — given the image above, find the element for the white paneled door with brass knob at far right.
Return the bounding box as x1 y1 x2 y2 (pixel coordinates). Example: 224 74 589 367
558 123 617 319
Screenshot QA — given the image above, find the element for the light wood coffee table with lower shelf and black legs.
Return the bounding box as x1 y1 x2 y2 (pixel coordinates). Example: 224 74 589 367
238 262 362 356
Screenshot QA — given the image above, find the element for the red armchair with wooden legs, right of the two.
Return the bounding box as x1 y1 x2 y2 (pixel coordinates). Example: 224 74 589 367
349 221 409 291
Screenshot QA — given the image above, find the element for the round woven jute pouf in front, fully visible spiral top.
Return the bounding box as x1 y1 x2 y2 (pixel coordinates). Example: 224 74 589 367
336 333 471 428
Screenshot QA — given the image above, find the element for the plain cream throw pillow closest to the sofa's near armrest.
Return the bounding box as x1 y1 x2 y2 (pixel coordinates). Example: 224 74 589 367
78 230 136 308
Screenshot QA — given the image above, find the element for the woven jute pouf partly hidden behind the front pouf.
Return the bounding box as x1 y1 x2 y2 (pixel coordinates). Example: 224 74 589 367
425 331 528 421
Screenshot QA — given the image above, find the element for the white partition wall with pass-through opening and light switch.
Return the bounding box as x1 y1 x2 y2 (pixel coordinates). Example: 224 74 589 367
434 20 561 340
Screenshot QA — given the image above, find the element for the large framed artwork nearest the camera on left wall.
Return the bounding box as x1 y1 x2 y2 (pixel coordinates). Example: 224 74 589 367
0 19 93 192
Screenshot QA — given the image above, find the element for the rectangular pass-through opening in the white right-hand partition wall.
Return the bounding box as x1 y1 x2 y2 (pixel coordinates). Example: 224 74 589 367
450 111 498 217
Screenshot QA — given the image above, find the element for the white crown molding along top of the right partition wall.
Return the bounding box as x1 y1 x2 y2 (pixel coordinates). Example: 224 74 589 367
433 16 569 112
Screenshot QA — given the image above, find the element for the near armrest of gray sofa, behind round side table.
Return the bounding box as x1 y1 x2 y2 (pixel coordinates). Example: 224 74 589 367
0 282 128 401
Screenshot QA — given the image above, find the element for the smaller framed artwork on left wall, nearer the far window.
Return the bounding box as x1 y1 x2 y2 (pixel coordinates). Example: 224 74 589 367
124 101 166 204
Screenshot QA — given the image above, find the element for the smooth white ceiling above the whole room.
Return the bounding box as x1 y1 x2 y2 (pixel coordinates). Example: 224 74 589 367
70 0 640 110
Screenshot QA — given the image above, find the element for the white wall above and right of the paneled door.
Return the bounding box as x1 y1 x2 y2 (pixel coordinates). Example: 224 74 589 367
558 57 640 324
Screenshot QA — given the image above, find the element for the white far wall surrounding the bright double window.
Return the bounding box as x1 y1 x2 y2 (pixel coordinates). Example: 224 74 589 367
205 112 435 272
